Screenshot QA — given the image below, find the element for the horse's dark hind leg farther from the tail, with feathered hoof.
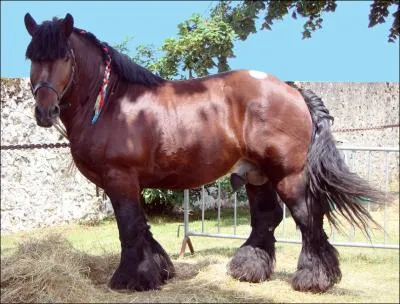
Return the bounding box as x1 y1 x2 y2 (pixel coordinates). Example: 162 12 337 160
228 182 283 282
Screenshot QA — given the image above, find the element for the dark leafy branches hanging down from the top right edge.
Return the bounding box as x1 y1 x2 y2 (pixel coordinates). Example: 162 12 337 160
211 0 400 42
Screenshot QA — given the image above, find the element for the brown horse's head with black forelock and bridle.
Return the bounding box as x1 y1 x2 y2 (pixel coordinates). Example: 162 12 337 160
25 13 75 127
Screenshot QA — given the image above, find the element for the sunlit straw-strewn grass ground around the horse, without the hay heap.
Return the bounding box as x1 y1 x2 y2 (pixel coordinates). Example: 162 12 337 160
1 203 399 303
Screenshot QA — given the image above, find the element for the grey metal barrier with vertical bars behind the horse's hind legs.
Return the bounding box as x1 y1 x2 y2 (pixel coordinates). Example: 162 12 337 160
178 146 399 255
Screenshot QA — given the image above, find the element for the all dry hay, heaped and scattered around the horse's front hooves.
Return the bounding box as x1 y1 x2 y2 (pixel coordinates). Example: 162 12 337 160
1 234 262 303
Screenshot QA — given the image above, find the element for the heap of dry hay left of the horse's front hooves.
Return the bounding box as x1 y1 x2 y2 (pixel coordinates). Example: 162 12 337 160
1 234 118 303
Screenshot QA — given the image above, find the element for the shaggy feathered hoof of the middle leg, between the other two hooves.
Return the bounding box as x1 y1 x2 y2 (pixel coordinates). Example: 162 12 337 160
228 246 274 283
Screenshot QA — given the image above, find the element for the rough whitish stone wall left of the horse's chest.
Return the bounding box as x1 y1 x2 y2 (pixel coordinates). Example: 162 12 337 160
1 79 110 232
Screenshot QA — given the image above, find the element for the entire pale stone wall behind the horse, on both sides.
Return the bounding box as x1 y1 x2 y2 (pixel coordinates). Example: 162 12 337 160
1 79 399 232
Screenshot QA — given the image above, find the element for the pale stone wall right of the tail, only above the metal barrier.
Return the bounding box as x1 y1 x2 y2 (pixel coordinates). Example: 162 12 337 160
298 82 399 147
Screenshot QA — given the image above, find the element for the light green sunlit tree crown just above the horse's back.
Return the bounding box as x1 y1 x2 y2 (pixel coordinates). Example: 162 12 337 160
133 14 235 79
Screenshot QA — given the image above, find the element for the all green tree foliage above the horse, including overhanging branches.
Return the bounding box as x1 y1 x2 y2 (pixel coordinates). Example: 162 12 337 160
117 0 400 79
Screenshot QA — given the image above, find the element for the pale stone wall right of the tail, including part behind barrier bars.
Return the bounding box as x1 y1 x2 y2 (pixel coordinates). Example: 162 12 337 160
296 82 399 191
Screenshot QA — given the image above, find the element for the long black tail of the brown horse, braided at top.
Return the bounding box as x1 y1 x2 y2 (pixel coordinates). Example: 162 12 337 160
298 88 386 235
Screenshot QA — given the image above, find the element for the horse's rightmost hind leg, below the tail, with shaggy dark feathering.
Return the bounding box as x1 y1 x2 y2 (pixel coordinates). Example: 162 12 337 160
277 173 341 292
